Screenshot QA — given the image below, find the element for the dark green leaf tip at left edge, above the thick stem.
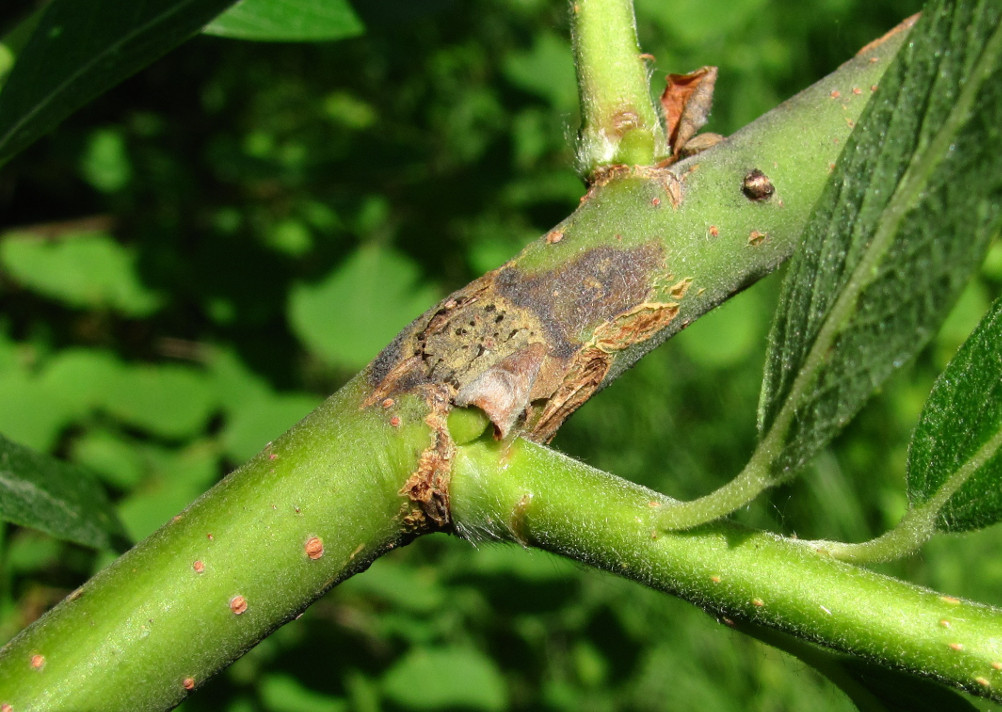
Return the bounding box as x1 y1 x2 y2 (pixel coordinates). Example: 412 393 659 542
0 428 124 549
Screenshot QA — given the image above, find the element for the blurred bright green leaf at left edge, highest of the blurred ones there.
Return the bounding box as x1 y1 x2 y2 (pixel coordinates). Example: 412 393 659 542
0 232 162 316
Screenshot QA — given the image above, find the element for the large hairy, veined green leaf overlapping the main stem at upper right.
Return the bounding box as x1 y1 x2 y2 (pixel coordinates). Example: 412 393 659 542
759 0 1002 472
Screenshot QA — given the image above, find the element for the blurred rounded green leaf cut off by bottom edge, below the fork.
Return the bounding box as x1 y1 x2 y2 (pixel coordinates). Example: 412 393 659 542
383 647 508 710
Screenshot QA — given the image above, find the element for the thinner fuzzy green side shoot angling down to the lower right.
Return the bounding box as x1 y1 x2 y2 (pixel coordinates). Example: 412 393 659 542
451 441 1002 700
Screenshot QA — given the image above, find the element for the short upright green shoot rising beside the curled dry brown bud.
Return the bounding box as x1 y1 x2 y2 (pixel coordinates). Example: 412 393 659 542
571 0 667 176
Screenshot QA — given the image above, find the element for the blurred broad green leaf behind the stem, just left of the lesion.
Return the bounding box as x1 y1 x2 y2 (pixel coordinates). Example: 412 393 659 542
289 245 437 371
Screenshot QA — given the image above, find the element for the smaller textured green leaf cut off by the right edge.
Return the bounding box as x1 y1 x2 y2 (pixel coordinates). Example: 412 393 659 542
908 298 1002 532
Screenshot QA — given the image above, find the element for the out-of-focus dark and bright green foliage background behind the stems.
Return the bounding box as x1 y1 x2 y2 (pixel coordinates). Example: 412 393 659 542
0 0 1002 712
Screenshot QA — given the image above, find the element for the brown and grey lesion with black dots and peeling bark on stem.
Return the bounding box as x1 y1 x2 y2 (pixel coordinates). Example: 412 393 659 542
366 236 688 444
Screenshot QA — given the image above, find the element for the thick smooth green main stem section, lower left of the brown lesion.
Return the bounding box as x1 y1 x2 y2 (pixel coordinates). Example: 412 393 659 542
0 377 428 712
